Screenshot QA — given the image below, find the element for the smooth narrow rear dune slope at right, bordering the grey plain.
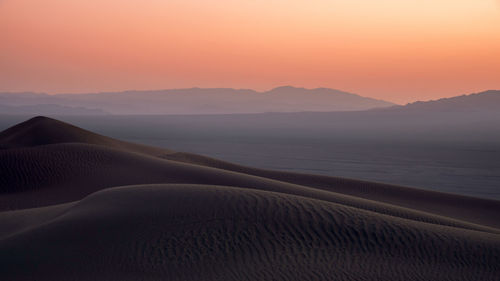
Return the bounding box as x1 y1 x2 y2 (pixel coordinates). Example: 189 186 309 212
160 152 500 227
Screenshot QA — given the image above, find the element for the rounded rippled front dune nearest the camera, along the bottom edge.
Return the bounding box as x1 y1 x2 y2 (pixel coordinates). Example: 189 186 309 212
0 185 500 281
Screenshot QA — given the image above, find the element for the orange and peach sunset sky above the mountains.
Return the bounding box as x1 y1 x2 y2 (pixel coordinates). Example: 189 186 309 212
0 0 500 103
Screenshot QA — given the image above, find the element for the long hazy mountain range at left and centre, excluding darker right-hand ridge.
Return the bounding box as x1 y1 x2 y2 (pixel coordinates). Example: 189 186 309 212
0 86 394 115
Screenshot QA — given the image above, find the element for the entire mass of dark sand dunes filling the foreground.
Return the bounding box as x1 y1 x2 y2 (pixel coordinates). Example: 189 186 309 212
0 117 500 280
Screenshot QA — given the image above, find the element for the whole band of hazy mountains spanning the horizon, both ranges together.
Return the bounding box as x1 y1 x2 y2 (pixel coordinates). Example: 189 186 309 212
0 86 500 118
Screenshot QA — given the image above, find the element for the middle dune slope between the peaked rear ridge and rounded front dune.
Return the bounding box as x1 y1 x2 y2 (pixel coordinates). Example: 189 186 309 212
0 144 498 232
